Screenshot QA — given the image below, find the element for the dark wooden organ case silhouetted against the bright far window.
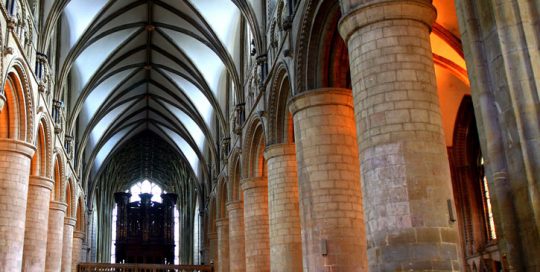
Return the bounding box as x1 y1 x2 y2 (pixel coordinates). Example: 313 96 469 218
114 193 177 264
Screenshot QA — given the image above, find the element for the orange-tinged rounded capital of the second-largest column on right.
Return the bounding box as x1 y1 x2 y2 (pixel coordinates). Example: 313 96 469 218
289 88 353 115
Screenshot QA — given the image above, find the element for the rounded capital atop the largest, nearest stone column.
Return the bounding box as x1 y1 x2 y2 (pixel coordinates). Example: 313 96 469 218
339 0 437 43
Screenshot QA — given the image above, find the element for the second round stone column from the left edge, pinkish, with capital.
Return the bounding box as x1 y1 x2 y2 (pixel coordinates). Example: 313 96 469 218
23 176 53 271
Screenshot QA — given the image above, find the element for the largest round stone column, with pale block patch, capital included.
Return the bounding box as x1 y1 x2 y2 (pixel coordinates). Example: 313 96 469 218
340 0 460 271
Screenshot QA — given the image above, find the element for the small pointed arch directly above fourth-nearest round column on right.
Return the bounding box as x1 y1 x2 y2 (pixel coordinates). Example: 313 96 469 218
242 116 265 178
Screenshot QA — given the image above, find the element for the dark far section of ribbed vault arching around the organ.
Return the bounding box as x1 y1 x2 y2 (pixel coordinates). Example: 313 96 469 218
90 130 198 261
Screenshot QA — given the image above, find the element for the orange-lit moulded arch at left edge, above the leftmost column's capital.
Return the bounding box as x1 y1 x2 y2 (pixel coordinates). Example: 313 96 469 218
0 59 34 143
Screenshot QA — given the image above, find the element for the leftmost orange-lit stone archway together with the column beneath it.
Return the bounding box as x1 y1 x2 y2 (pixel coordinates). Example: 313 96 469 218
0 65 35 271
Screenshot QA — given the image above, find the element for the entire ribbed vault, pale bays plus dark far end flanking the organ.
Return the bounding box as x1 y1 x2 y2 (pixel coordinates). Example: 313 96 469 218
45 0 248 262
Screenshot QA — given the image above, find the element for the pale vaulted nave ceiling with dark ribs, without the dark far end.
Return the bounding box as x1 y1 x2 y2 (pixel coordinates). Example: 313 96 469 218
42 0 255 193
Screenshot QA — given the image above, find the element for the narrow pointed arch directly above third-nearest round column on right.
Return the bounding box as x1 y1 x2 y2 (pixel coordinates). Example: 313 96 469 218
267 64 294 145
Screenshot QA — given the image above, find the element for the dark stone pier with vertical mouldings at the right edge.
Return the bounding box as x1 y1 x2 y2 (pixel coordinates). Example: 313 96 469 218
455 0 540 271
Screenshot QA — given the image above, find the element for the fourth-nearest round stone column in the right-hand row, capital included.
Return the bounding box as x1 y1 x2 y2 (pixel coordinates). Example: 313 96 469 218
241 177 270 272
